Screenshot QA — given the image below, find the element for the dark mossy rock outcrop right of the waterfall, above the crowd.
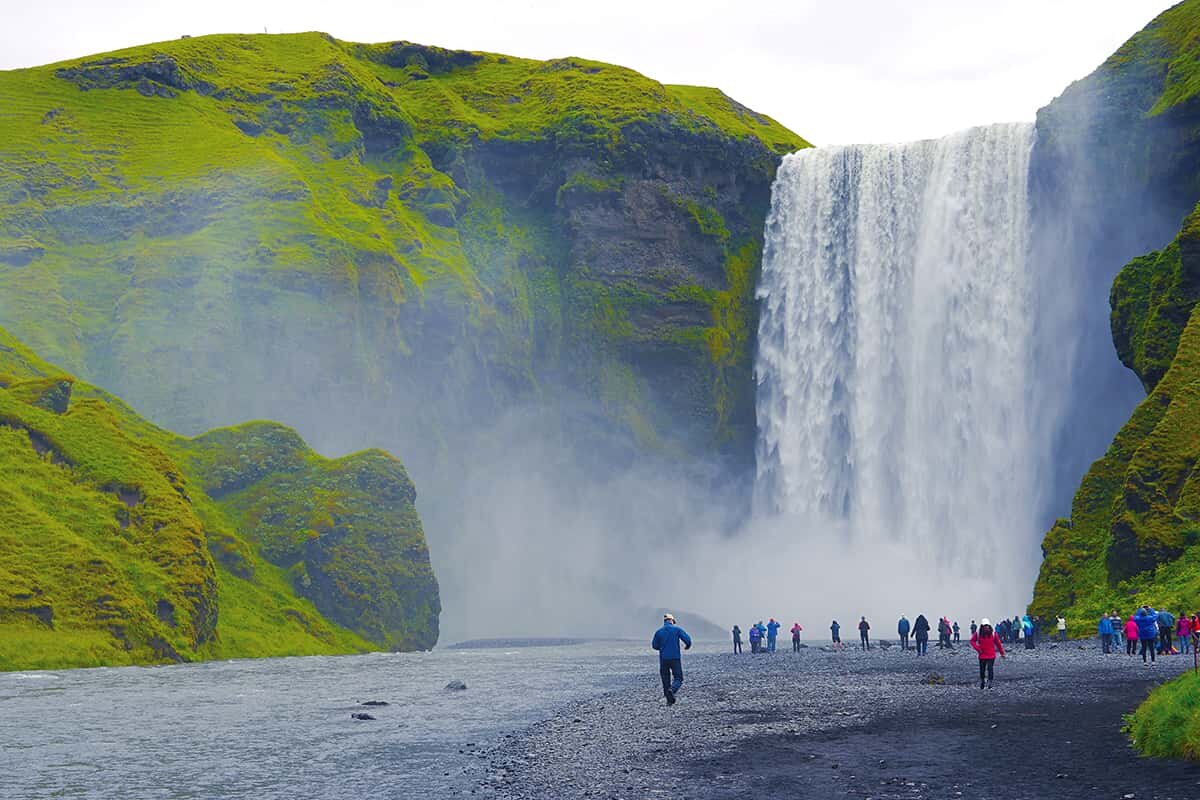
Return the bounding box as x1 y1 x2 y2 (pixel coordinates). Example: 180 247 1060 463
1032 203 1200 619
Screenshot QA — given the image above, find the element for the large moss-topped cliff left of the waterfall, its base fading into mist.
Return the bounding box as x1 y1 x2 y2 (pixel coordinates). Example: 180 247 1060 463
0 34 806 482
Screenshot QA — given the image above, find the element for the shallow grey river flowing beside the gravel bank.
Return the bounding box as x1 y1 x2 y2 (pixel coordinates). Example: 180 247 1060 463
0 642 658 800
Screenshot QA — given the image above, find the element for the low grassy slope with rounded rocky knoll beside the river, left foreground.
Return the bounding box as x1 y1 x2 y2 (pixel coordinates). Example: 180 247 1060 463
0 330 438 669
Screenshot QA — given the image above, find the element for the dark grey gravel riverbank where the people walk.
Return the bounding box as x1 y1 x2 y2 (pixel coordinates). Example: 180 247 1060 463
472 642 1200 800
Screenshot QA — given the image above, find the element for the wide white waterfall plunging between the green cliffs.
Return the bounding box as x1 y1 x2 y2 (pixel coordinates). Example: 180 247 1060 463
756 124 1044 573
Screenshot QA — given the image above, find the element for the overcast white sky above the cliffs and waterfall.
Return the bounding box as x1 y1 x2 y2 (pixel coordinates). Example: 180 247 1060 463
0 0 1171 144
